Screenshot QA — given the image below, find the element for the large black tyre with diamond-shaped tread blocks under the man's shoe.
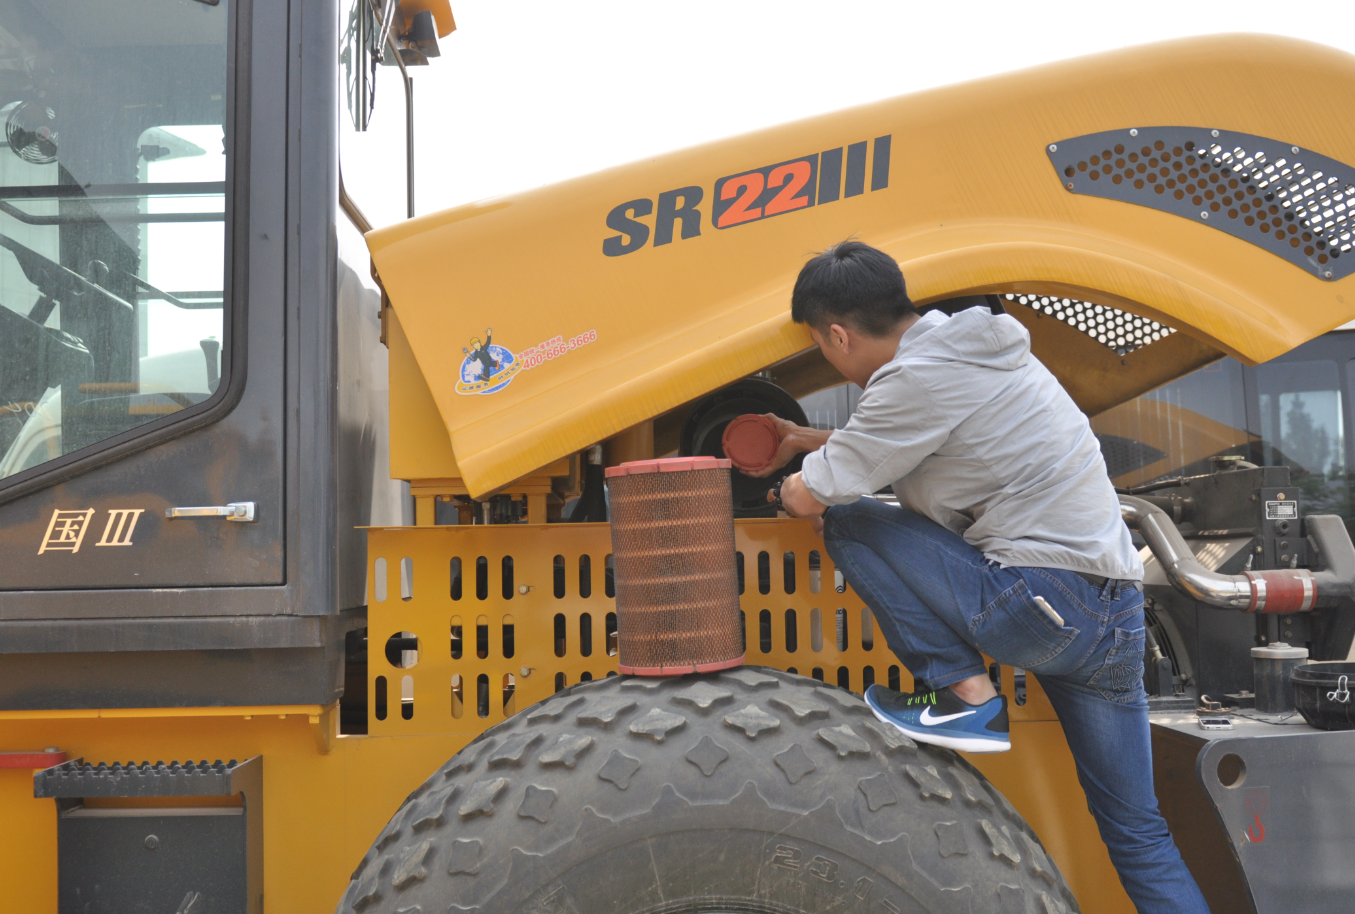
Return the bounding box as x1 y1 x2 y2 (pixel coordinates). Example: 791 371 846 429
339 666 1079 914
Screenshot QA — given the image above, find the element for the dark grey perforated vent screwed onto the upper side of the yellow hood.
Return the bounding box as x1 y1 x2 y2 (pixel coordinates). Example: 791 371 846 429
1046 127 1355 280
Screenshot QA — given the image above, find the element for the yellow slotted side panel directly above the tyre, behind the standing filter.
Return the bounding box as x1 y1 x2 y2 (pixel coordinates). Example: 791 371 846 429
367 520 1056 735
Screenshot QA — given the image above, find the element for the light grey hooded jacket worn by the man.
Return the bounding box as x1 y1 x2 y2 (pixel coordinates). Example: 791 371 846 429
804 307 1144 581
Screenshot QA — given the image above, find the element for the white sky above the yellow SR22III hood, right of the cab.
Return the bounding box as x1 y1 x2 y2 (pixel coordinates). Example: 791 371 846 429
395 0 1355 223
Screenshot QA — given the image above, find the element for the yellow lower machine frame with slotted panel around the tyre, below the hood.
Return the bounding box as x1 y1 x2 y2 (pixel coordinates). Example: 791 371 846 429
0 519 1116 914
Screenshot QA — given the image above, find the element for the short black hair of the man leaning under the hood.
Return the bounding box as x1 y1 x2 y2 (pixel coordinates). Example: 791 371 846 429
790 241 917 337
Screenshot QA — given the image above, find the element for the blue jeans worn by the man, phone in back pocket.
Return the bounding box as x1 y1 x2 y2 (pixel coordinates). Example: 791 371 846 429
824 498 1209 914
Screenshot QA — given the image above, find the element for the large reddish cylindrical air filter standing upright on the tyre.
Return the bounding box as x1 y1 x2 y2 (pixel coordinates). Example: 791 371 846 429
607 456 744 676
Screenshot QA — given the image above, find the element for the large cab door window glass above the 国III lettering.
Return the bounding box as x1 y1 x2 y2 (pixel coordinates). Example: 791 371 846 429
0 0 232 485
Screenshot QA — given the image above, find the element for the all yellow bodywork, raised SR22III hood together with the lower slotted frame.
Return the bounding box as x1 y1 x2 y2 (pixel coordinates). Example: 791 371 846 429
0 37 1355 914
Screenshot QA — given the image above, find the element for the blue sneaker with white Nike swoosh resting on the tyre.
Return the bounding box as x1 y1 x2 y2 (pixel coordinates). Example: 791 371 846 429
866 685 1012 752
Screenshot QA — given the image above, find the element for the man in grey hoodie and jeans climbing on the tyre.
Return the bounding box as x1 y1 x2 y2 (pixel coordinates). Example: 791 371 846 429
768 241 1209 914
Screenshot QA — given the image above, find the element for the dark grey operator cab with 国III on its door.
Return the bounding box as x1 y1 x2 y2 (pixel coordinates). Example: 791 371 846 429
0 0 454 708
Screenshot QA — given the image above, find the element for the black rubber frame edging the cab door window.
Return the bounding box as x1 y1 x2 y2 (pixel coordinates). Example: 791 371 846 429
0 0 253 505
